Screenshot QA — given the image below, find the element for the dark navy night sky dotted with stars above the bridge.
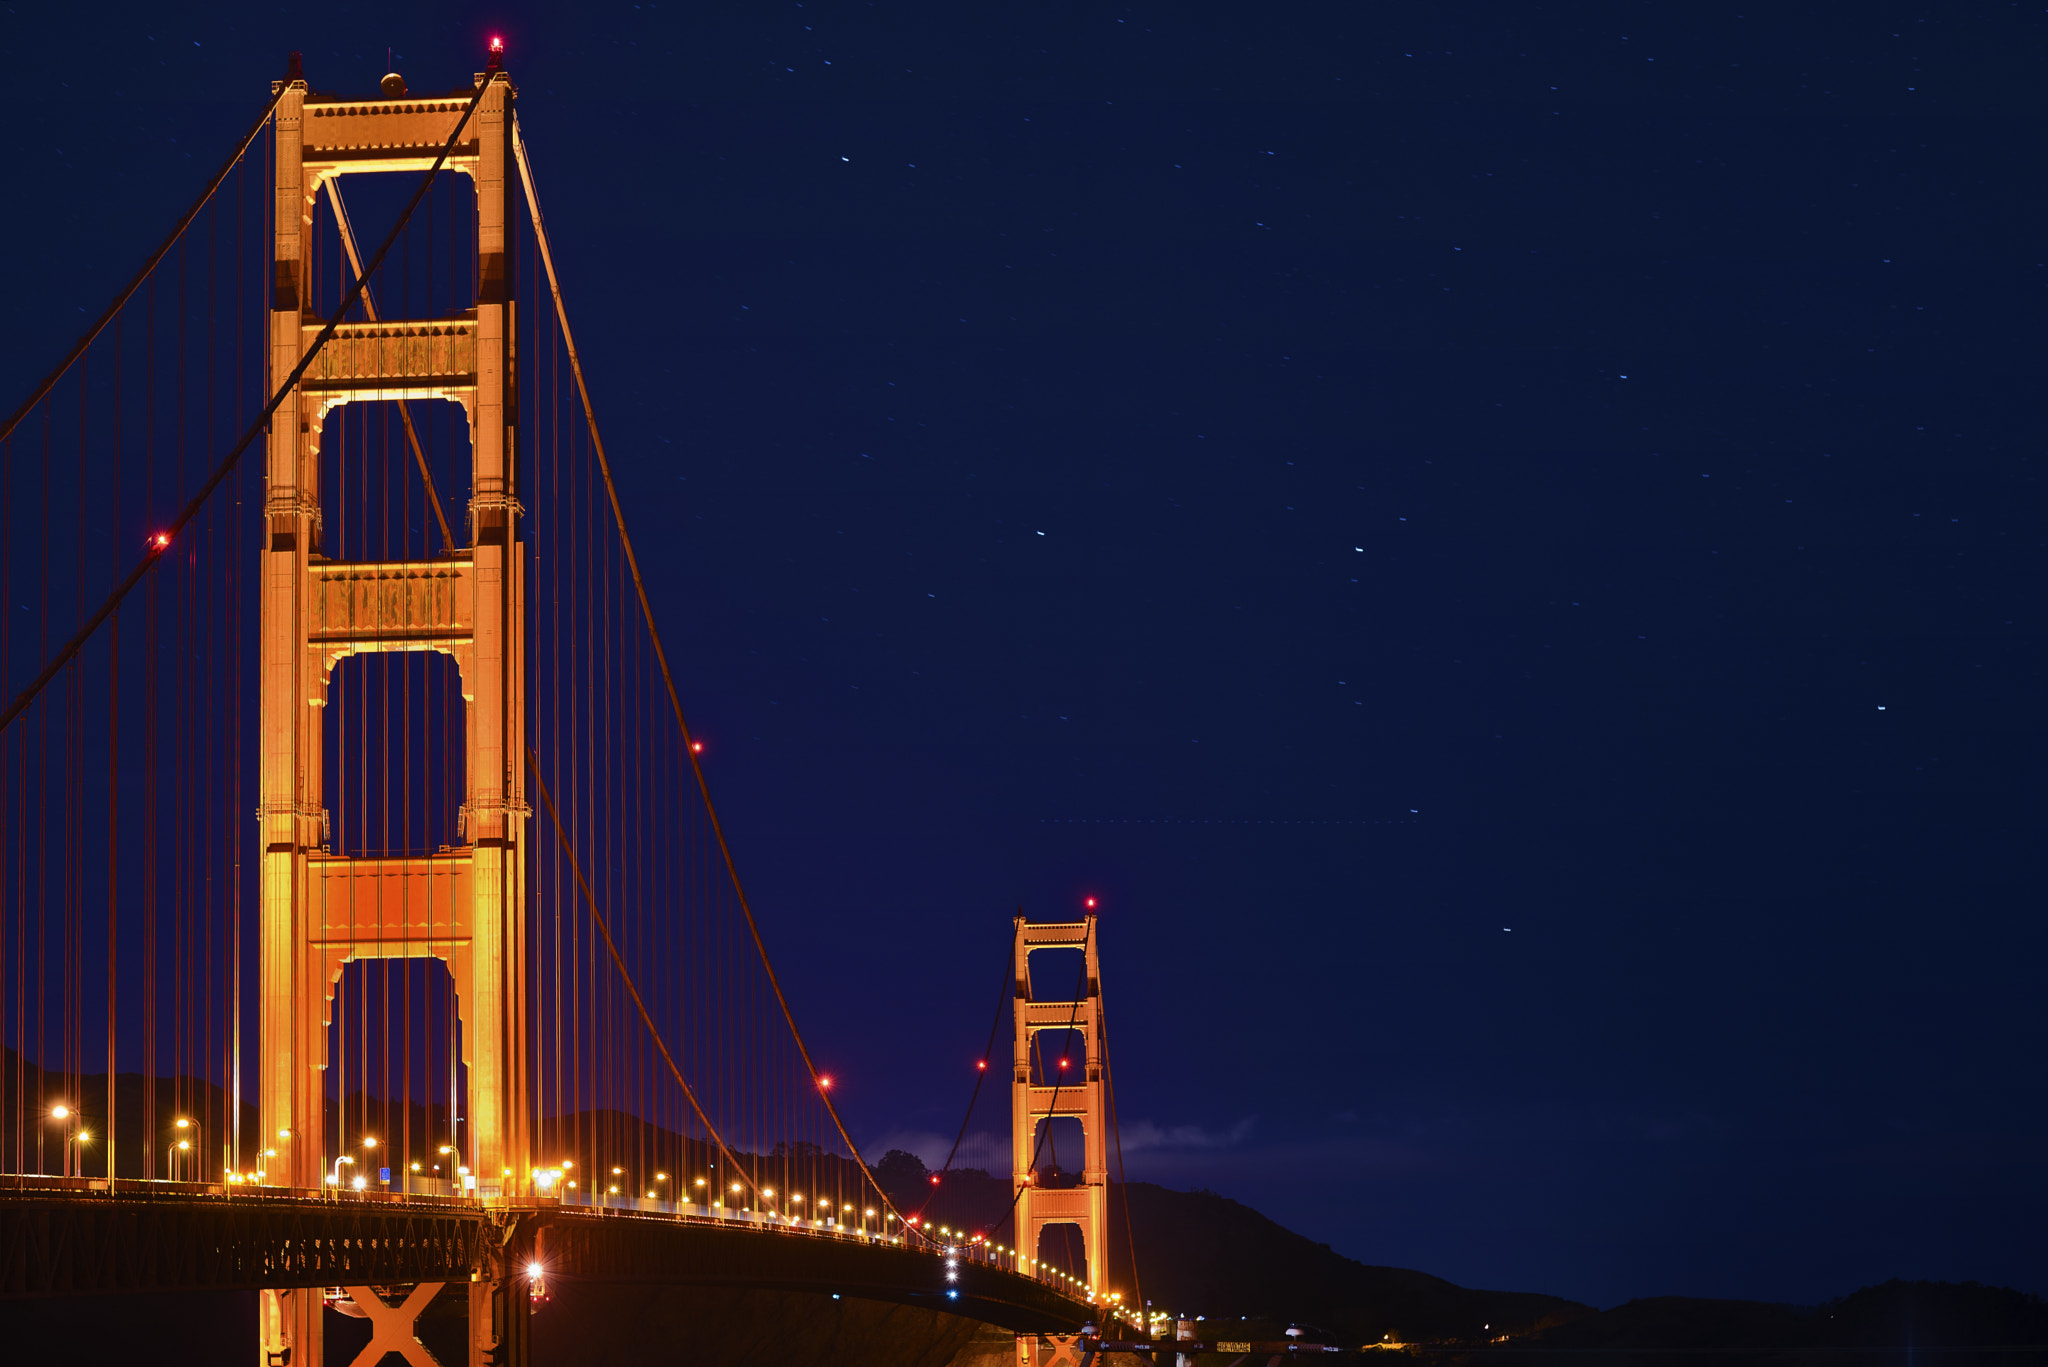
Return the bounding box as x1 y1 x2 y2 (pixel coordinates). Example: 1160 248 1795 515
0 0 2048 1303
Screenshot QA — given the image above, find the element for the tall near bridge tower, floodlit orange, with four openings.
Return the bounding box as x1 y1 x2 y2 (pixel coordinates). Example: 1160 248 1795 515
258 57 532 1367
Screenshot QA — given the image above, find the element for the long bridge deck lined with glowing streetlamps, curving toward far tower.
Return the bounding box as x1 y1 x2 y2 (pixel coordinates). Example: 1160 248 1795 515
0 1178 1094 1332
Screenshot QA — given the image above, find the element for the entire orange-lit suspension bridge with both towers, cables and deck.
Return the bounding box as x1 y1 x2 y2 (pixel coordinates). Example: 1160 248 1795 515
0 41 1143 1367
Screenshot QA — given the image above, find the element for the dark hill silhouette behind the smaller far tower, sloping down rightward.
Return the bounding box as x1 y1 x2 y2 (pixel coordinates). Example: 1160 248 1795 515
874 1150 2048 1367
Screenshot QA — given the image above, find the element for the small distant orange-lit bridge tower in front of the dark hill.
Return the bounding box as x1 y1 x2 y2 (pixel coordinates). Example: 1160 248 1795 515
1010 912 1110 1291
